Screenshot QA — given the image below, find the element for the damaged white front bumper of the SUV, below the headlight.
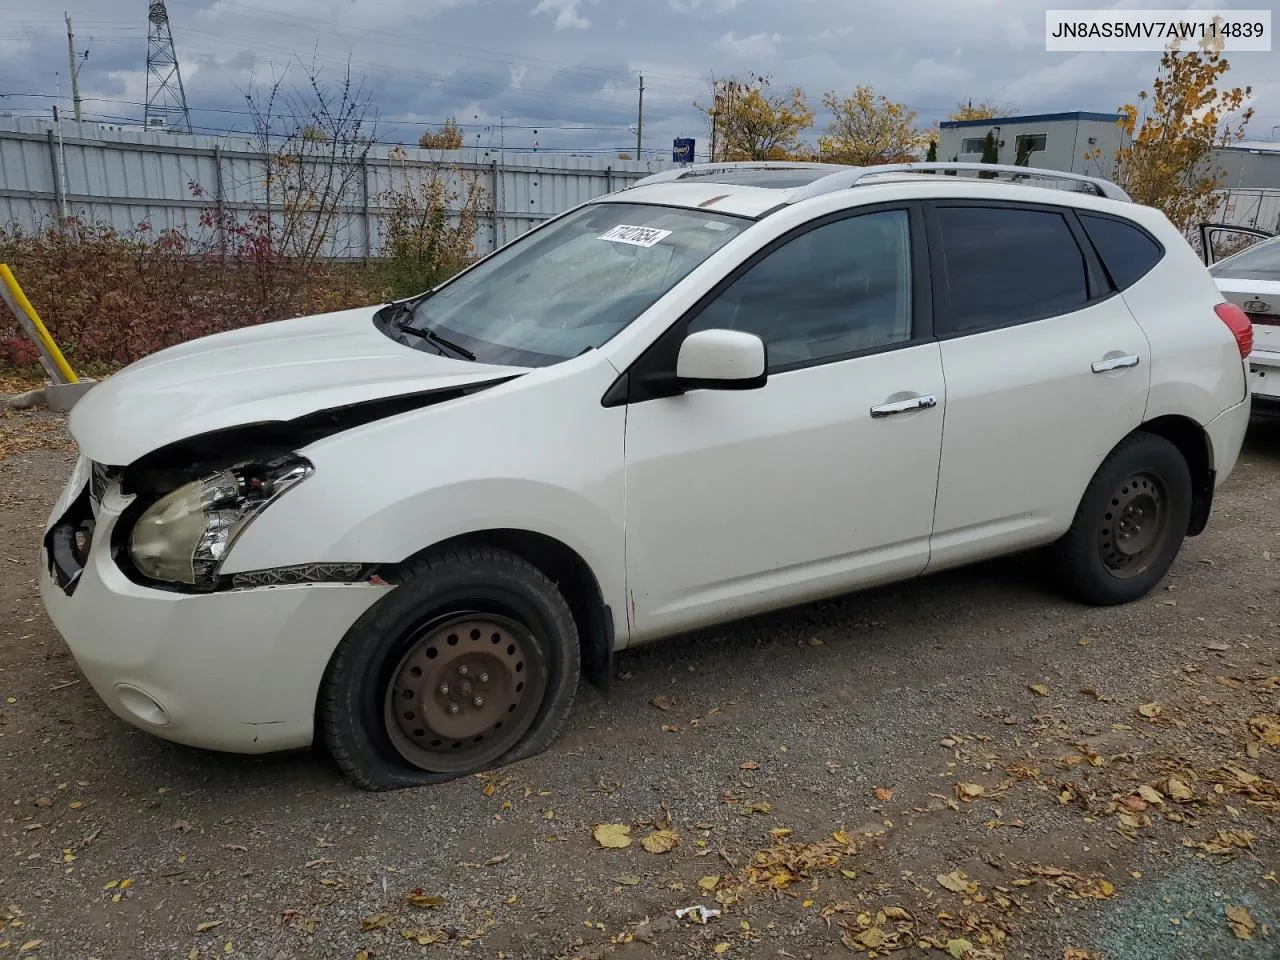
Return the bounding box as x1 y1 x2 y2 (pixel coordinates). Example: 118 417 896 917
40 463 388 753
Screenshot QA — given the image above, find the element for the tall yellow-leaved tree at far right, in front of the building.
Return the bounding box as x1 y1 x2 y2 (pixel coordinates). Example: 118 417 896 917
1116 46 1253 230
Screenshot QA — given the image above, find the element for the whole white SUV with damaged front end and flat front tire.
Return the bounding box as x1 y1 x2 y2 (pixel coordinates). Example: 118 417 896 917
42 164 1251 788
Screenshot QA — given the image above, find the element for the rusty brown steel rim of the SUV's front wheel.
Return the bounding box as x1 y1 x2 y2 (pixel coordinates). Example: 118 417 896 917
373 613 547 773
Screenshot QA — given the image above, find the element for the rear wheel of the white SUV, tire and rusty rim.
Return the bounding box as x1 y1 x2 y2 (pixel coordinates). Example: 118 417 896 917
1051 431 1193 607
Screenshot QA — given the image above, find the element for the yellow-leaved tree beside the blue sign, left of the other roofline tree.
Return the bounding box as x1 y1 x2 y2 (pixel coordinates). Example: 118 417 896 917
694 73 813 161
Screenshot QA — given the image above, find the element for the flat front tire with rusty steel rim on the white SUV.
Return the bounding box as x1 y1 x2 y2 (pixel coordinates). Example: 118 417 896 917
317 547 581 790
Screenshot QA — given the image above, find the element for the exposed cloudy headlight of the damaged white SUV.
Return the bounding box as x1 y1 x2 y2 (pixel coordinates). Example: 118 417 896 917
128 456 314 589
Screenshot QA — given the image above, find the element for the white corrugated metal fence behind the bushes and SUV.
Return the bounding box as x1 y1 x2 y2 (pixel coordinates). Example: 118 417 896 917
0 118 671 259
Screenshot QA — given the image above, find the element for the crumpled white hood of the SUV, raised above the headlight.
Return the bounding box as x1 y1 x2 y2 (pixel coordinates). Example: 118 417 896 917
68 306 527 466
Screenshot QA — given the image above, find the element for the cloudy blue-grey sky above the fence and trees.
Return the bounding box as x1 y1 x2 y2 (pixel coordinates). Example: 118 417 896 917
0 0 1280 155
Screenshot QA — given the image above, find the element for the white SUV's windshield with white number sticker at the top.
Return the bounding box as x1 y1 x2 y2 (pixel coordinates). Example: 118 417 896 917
407 202 753 366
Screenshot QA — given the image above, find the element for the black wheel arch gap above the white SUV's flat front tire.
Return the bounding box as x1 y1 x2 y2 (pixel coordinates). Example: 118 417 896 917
379 527 614 691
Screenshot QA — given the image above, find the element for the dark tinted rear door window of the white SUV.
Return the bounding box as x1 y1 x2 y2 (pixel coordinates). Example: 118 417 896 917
937 206 1089 333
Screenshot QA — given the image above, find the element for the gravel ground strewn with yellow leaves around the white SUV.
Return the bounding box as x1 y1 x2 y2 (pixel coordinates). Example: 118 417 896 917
0 412 1280 960
